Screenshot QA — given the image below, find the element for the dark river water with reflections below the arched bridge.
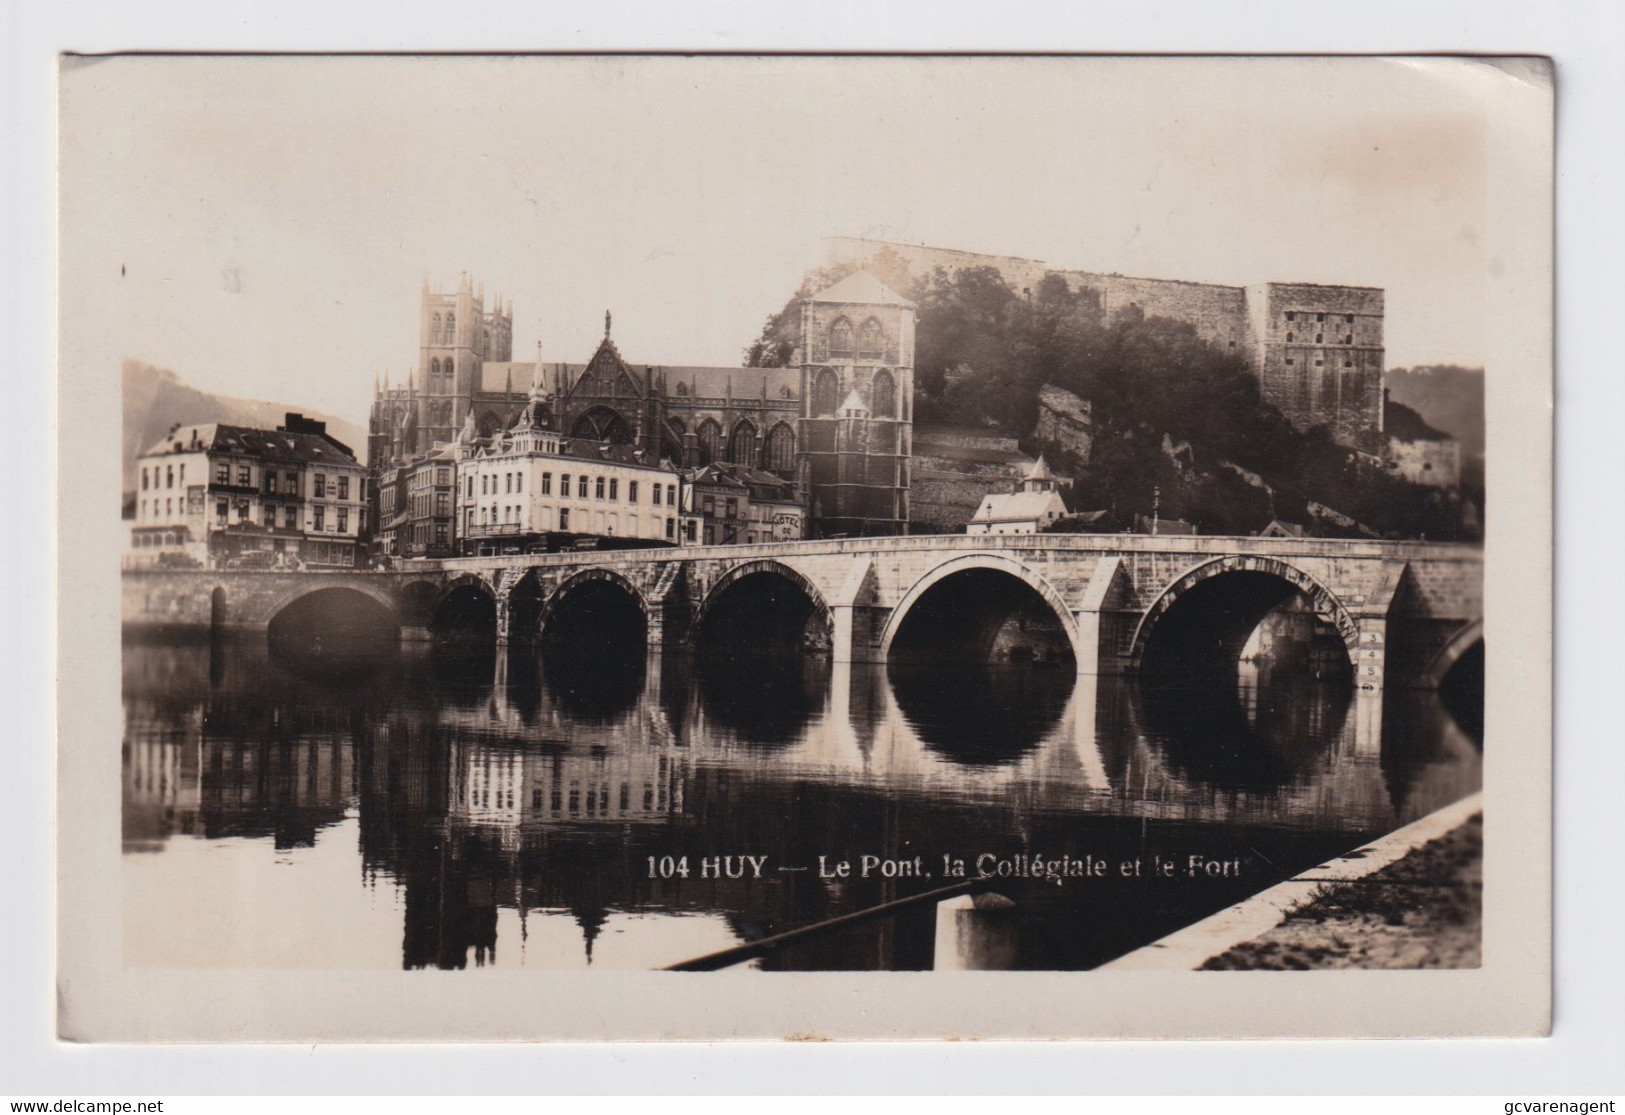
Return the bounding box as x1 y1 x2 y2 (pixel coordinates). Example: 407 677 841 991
124 637 1482 970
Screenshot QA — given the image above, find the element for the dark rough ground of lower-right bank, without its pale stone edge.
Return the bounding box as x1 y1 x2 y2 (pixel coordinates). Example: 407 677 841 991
1203 814 1484 972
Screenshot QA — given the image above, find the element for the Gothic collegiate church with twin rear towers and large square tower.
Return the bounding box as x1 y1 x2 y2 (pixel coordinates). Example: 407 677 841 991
367 271 915 538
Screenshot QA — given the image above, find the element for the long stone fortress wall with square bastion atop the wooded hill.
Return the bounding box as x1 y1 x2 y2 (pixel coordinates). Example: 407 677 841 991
824 236 1385 455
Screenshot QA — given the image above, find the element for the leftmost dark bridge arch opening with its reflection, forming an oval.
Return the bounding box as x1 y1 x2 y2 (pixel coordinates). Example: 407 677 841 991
267 588 401 679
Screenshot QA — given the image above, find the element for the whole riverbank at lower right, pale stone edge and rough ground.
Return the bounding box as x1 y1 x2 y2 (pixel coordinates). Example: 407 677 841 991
1103 793 1484 972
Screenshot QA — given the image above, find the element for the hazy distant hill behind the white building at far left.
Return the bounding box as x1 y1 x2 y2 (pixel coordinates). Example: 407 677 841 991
124 359 367 491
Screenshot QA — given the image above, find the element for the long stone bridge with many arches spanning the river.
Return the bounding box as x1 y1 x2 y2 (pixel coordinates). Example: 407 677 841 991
124 535 1484 691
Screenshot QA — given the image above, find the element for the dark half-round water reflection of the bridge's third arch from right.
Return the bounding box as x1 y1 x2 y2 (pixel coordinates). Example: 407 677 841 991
886 663 1076 767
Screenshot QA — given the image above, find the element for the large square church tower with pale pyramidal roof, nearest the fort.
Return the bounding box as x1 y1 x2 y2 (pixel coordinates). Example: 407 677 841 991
798 271 915 538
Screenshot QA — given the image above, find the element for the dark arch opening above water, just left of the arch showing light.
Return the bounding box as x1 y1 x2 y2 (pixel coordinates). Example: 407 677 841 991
889 569 1074 666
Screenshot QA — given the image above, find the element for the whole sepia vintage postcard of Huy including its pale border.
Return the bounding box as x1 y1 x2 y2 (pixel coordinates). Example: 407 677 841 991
59 55 1554 1042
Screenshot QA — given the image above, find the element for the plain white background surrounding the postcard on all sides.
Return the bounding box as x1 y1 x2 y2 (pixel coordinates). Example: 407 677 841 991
0 0 1625 1110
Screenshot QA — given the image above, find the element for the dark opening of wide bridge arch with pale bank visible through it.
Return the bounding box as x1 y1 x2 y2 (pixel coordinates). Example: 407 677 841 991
1141 569 1354 689
